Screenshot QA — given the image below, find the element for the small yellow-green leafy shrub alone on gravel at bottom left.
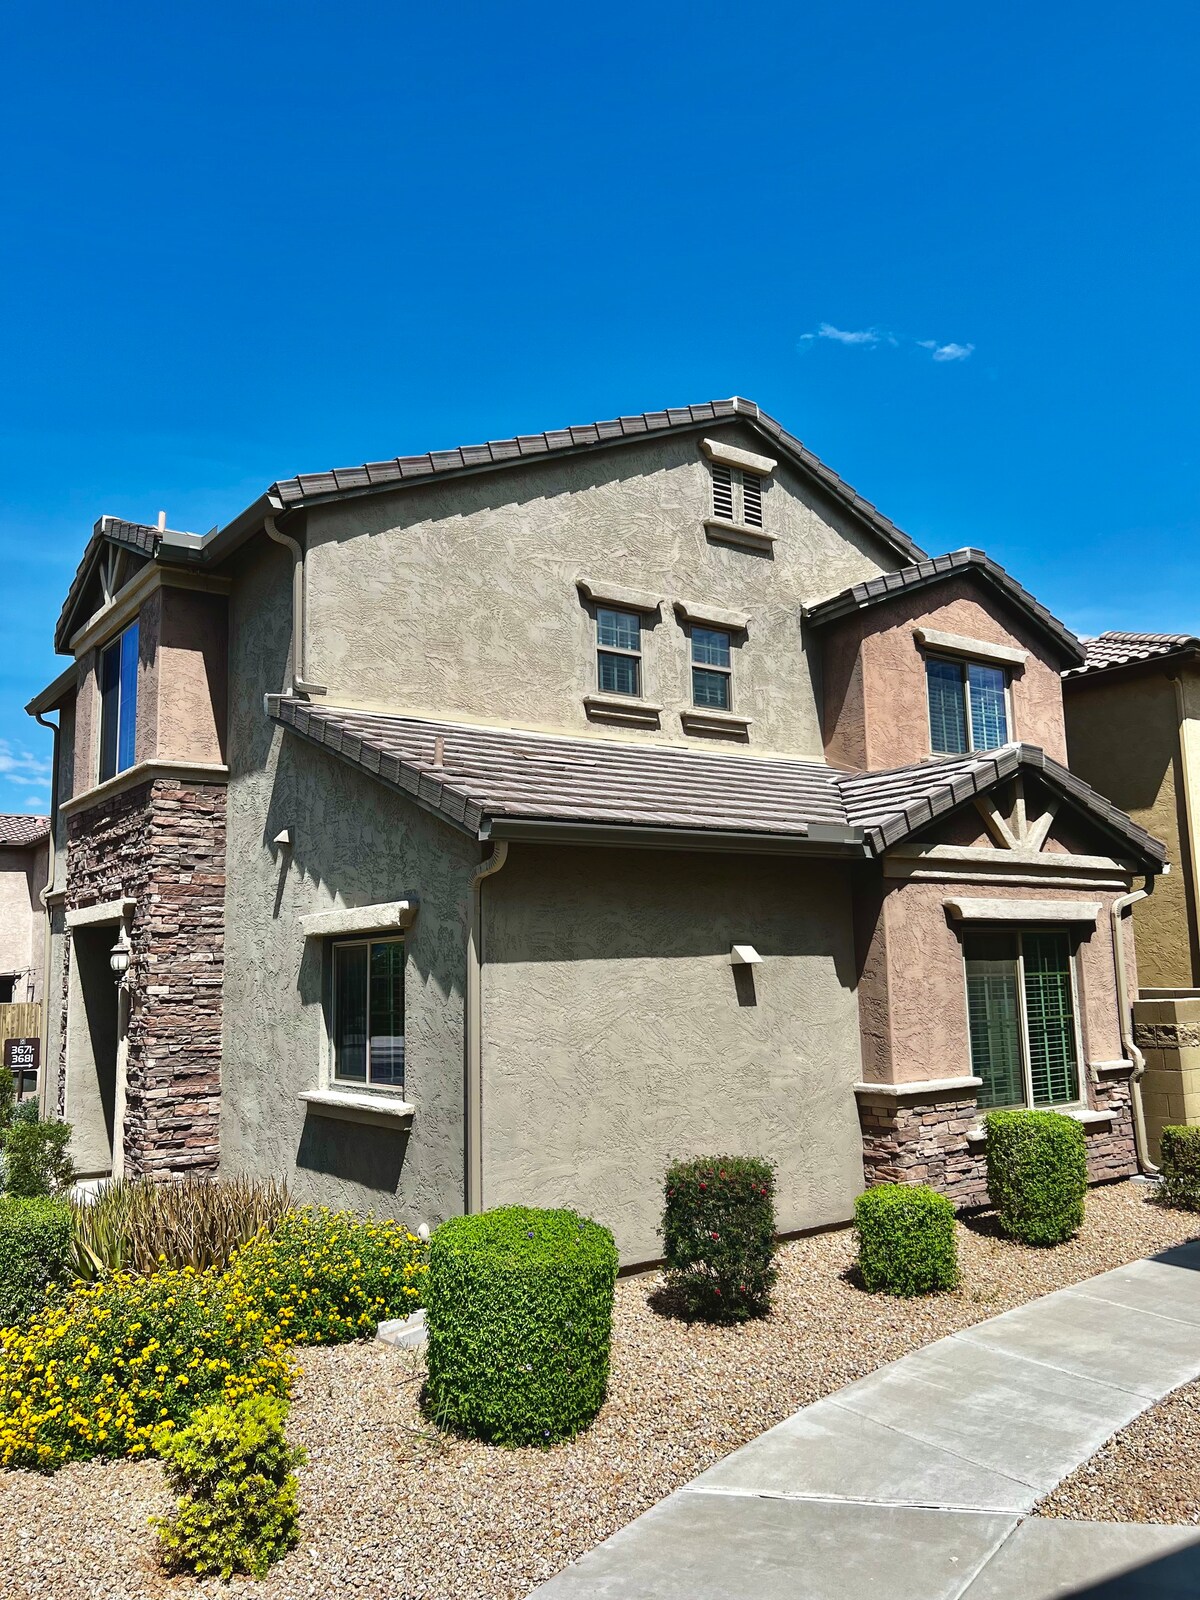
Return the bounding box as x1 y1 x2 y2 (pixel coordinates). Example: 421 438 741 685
150 1395 304 1579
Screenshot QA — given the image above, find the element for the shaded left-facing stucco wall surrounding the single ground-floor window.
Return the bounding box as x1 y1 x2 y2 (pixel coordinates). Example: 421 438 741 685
221 546 480 1226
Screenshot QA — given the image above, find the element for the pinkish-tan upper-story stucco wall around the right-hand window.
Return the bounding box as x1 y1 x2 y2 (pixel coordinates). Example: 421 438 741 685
824 578 1066 770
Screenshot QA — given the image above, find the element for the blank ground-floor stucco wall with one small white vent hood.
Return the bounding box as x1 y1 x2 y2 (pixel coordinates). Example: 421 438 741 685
483 846 862 1262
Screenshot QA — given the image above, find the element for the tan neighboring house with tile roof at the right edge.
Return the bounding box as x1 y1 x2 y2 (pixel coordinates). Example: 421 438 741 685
1062 634 1200 1158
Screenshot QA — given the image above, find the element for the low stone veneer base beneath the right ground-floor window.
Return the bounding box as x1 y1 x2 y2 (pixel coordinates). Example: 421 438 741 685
859 1074 1138 1206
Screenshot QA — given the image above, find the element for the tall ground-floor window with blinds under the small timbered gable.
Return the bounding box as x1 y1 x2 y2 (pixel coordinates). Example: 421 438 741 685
963 928 1080 1110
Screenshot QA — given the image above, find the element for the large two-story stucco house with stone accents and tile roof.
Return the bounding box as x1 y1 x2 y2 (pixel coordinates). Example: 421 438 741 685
23 400 1163 1261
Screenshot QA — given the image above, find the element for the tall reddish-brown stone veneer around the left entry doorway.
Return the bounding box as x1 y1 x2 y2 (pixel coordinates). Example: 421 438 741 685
58 778 226 1176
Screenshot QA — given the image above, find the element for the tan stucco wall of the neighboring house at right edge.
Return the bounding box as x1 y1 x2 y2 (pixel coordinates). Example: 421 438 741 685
1064 670 1200 989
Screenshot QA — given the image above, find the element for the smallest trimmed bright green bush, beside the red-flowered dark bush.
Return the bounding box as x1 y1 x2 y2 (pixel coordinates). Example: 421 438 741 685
854 1184 958 1296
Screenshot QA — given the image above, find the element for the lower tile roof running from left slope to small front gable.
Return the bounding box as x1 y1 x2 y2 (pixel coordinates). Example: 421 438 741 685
270 696 1166 872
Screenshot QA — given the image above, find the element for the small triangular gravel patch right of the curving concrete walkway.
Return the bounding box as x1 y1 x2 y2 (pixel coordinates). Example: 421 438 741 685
1035 1384 1200 1523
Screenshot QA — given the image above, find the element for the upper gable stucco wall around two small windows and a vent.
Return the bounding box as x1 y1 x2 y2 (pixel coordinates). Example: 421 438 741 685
300 426 899 758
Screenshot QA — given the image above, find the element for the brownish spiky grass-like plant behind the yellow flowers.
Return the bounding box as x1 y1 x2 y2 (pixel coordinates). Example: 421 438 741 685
72 1178 291 1282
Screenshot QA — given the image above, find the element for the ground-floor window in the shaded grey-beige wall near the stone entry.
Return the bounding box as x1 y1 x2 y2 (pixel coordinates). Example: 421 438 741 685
331 939 405 1090
